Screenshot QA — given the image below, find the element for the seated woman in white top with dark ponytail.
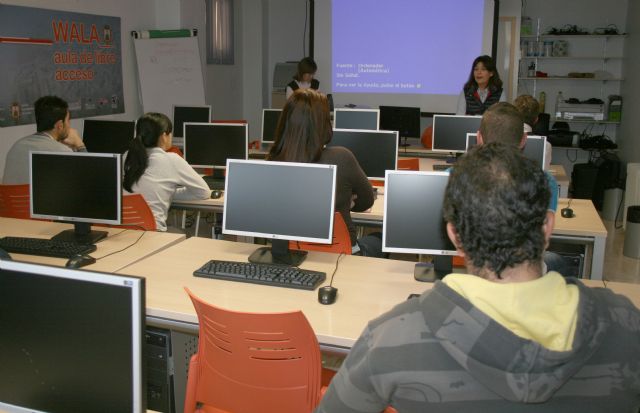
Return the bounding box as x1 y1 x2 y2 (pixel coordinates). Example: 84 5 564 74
123 113 211 231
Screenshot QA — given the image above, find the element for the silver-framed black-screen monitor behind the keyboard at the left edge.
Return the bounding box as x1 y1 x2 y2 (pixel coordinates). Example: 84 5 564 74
29 152 122 244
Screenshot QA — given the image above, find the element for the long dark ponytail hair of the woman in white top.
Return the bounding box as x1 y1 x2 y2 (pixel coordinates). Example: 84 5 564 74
122 112 173 192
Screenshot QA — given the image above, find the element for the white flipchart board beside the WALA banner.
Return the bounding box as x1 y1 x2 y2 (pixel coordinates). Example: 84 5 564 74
133 36 205 118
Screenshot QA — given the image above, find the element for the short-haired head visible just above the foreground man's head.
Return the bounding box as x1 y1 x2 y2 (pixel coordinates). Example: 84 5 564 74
478 102 527 148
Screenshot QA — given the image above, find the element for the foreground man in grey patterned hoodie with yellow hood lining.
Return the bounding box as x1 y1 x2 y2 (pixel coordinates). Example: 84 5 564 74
316 143 640 413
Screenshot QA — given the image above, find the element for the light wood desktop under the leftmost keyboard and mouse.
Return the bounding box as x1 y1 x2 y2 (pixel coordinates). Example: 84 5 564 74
0 217 186 272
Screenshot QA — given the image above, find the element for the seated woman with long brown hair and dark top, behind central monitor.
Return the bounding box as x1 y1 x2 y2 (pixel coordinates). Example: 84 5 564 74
267 89 382 257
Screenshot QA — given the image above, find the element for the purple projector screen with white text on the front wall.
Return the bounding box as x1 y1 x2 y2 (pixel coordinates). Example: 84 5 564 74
314 0 494 110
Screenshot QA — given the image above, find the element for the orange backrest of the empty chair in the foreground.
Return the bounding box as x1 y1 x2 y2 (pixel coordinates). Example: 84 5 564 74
184 287 321 413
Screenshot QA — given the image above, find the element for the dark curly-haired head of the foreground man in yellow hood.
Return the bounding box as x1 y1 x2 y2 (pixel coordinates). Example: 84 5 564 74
443 142 554 279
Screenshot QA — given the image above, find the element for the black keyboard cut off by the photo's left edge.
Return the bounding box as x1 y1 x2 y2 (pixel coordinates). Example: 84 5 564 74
0 237 96 258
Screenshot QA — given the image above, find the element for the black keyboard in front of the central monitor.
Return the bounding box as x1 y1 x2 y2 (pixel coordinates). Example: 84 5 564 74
193 260 326 290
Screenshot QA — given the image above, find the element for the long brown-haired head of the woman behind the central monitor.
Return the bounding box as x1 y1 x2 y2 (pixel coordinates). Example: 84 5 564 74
269 89 332 162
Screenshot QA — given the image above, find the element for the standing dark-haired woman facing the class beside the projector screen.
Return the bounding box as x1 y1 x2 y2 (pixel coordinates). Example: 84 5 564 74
456 55 507 115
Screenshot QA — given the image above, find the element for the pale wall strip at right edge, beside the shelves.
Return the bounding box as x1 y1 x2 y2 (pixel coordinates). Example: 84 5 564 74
618 0 640 162
